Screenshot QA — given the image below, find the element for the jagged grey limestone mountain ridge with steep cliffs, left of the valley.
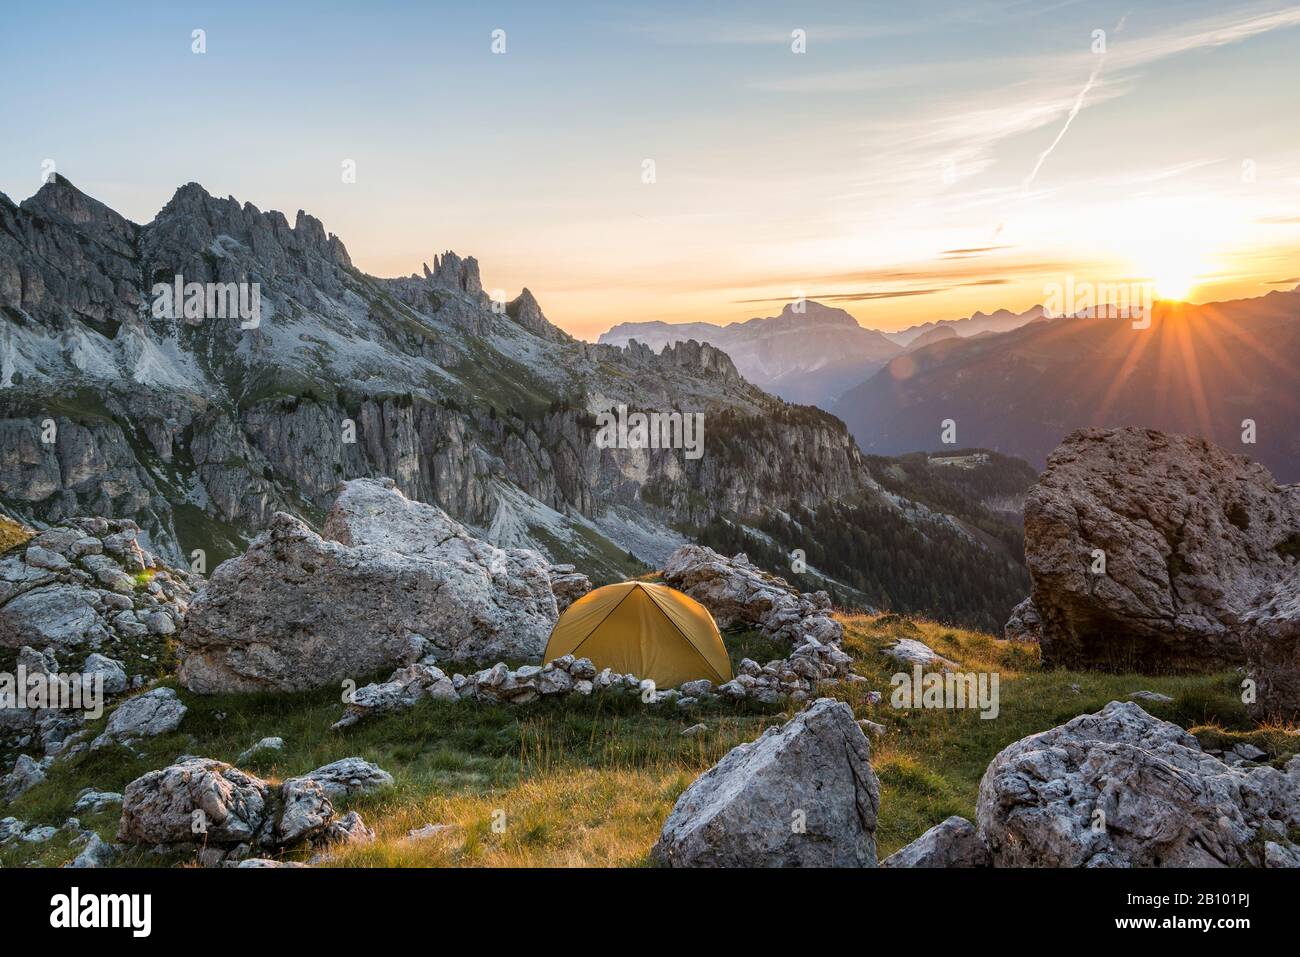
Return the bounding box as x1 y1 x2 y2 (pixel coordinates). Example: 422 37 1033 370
0 177 883 574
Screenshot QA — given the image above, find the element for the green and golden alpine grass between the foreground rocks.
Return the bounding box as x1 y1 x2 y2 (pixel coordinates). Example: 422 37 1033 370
0 615 1300 866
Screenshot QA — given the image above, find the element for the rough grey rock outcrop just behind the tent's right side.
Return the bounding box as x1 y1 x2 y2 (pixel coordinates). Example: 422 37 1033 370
663 545 844 645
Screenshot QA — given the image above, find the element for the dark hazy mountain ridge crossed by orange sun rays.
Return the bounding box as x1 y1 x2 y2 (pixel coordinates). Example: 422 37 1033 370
831 287 1300 481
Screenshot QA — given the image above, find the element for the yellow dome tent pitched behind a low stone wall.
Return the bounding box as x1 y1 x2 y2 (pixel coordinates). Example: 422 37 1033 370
543 581 732 688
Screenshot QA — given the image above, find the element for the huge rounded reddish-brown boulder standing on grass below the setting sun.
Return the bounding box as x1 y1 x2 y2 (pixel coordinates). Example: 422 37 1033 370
1021 429 1300 670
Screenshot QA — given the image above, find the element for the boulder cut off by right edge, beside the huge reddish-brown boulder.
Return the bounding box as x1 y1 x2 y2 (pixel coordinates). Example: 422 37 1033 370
1243 573 1300 722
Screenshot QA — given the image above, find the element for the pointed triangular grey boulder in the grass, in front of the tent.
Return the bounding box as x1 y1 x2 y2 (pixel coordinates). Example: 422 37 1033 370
653 698 880 867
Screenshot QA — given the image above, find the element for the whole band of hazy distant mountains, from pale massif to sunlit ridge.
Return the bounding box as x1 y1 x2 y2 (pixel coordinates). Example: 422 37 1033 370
601 287 1300 481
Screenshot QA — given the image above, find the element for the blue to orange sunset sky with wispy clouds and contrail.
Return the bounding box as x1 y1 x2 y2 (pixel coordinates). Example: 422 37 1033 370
0 0 1300 338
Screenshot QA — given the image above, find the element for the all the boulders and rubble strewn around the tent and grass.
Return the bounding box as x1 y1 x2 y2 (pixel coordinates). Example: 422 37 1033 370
0 429 1300 867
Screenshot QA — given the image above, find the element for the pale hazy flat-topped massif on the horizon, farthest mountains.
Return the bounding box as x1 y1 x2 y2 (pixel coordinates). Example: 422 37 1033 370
599 300 1043 408
